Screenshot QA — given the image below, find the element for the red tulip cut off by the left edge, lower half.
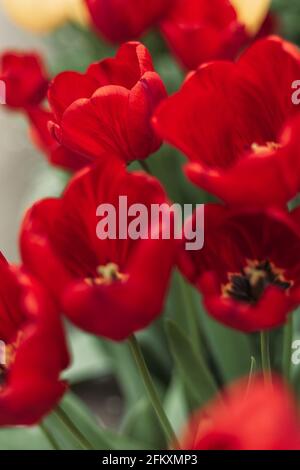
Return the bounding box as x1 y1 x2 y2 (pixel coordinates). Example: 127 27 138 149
0 257 68 426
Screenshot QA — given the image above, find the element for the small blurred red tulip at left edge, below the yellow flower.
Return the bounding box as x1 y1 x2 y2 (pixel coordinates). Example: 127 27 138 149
0 51 48 111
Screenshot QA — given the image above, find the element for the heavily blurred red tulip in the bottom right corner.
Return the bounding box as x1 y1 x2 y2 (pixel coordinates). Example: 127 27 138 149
181 376 300 450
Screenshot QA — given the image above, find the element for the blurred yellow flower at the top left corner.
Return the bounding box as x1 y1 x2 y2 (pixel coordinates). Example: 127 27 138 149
1 0 88 33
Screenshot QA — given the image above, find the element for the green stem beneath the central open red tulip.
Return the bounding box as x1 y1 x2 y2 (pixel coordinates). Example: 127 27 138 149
129 335 180 449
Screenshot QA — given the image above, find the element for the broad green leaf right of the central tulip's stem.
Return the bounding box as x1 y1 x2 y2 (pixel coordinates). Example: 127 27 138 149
166 321 218 406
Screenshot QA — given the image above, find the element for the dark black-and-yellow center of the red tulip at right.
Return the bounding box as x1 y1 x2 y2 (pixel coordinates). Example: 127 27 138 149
222 260 293 304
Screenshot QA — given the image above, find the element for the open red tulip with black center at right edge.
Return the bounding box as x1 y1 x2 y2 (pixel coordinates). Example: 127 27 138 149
180 204 300 332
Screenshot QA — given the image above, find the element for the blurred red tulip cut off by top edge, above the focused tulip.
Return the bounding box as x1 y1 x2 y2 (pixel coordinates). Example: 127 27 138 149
86 0 174 43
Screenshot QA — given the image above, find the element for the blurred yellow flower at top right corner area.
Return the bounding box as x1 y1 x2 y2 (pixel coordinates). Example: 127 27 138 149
230 0 271 36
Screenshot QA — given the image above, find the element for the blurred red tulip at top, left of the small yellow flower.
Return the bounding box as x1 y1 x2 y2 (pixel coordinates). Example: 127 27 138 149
161 0 249 69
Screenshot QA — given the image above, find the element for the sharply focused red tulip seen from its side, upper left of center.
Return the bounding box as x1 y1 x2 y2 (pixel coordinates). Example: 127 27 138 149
49 42 166 167
